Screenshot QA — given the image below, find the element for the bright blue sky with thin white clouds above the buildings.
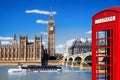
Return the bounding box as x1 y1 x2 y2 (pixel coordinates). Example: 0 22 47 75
0 0 120 52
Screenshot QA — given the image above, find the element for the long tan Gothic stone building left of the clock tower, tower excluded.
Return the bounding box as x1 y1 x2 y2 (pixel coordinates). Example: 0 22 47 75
0 35 44 65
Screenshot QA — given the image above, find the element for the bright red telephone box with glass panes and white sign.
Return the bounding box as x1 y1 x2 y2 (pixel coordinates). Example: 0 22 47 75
92 6 120 80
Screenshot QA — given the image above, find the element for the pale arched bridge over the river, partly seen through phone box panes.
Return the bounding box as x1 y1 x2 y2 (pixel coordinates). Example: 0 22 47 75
63 51 106 69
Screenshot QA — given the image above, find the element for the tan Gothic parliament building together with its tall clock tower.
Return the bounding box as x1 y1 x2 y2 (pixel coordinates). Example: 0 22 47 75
0 12 55 65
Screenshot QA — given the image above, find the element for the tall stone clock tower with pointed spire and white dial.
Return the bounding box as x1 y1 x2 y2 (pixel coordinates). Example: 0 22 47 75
48 11 55 56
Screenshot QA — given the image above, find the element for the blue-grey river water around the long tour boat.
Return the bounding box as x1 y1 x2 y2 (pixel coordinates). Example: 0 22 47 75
0 66 91 80
